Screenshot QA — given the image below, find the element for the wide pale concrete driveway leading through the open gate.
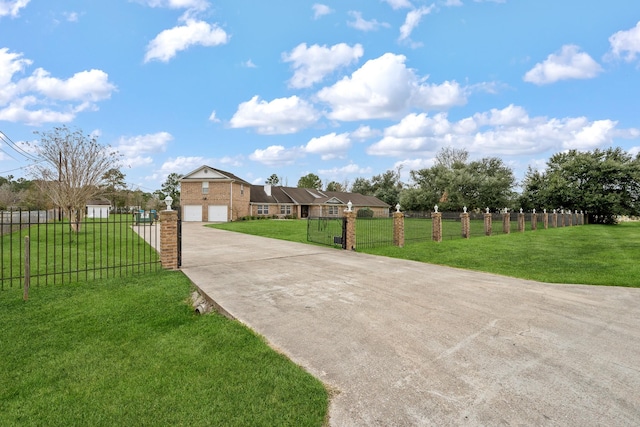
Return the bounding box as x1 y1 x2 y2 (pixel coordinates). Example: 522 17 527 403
183 223 640 426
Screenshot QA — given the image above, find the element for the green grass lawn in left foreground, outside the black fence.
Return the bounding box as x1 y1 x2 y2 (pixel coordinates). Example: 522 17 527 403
0 271 328 426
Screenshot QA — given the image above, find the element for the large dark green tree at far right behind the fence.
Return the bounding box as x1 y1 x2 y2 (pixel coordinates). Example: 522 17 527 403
523 147 640 223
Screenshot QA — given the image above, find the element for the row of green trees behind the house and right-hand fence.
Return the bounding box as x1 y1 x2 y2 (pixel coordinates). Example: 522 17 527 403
278 147 640 224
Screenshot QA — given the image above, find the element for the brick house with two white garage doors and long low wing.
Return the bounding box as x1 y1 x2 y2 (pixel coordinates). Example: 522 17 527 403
180 165 389 222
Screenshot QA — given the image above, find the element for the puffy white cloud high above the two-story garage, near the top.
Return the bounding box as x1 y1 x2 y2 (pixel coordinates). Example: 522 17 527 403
144 19 230 62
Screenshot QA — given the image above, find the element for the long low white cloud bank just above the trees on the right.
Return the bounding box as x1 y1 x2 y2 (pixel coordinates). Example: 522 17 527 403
367 105 637 157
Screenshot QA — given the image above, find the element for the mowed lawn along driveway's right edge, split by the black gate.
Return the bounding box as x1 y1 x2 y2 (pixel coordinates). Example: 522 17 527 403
210 220 640 287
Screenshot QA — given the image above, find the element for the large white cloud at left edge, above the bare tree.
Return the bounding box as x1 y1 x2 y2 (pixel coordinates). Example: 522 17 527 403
0 48 116 125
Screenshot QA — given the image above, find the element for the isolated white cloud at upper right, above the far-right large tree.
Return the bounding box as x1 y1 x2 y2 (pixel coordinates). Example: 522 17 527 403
524 45 602 85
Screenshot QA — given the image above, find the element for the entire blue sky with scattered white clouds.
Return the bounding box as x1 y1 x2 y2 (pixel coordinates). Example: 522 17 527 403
0 0 640 191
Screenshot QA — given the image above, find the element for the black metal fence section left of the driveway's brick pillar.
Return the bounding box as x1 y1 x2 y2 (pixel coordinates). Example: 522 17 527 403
0 211 160 290
